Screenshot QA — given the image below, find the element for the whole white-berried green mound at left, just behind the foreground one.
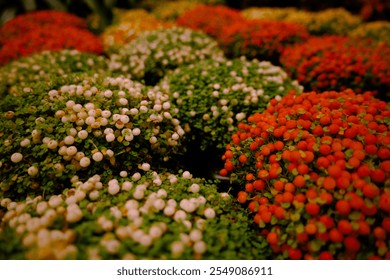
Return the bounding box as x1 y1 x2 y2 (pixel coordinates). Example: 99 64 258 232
0 77 184 199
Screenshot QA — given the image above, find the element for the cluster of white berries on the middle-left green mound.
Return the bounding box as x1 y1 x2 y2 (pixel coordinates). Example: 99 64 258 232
5 77 185 186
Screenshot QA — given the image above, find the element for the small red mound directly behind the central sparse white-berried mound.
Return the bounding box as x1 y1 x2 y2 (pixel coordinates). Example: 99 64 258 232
218 20 309 63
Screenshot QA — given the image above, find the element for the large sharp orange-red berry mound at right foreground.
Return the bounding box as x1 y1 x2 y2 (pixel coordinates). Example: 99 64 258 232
220 90 390 259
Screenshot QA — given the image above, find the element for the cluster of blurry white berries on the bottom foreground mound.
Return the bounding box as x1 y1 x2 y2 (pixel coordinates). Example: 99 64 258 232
0 168 232 259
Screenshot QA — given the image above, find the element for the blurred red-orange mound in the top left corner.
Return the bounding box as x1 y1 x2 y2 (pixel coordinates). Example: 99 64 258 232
0 11 103 65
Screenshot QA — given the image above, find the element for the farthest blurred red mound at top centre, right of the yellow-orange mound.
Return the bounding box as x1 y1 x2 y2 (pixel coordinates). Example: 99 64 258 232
176 5 244 39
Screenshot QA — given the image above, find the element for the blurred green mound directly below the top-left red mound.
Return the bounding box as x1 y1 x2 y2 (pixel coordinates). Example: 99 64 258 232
0 50 108 98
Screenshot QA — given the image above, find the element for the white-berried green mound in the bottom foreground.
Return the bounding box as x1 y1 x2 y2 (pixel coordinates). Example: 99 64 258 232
0 170 270 260
